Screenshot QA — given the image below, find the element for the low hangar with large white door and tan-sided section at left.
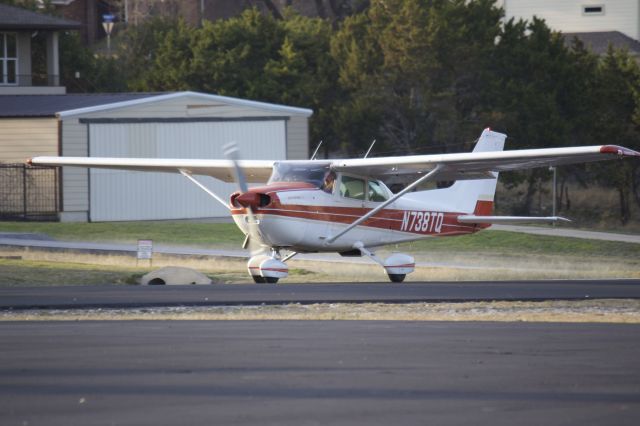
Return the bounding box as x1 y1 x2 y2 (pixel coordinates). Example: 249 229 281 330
0 92 312 221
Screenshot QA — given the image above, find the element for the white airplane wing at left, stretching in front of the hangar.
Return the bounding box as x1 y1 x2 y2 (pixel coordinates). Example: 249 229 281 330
28 157 274 183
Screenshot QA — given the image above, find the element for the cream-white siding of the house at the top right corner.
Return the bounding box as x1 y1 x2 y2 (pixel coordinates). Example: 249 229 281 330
499 0 640 40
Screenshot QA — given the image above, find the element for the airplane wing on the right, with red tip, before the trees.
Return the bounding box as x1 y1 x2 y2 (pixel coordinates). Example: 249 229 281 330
332 145 640 180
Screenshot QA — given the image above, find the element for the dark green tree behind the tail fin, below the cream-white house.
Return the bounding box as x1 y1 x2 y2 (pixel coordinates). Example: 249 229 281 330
489 17 597 214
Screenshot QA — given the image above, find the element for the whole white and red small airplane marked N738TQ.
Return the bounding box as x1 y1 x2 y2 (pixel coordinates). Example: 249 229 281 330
28 129 640 283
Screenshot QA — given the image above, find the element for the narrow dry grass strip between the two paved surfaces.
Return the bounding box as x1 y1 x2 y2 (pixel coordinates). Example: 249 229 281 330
0 300 640 324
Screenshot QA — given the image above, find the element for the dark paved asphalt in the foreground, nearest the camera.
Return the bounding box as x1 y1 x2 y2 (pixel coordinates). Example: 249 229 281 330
0 321 640 426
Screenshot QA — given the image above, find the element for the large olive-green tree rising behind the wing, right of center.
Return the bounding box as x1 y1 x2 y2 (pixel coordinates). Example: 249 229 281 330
332 0 502 156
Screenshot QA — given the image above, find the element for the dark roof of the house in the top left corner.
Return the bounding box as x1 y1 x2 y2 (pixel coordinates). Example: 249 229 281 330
0 4 82 30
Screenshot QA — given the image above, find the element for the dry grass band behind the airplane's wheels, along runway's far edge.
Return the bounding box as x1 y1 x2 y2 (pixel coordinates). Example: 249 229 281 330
0 243 640 285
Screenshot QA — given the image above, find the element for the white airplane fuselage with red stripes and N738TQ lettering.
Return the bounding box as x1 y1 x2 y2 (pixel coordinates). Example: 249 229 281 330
231 182 486 252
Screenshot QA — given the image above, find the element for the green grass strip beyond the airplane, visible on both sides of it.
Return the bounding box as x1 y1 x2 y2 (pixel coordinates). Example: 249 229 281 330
0 221 640 259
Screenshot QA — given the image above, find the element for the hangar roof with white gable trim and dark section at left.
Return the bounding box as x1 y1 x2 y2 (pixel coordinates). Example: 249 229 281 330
0 92 313 118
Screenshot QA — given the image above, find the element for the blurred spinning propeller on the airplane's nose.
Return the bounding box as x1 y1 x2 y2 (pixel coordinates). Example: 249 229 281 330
223 142 268 256
